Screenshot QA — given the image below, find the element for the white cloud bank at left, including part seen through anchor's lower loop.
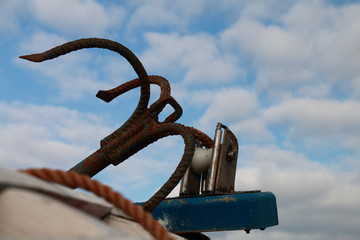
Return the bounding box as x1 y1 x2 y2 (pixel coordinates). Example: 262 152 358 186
0 102 190 201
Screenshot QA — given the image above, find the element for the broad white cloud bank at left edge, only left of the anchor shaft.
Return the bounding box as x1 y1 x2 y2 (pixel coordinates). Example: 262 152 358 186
0 103 110 169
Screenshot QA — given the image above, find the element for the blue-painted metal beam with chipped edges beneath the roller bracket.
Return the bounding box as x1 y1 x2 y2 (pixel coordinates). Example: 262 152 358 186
138 192 279 233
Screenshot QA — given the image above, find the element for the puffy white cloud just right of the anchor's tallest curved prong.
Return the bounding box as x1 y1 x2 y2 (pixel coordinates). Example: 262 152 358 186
141 33 242 85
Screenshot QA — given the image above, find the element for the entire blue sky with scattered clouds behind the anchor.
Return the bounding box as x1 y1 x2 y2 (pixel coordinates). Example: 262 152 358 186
0 0 360 240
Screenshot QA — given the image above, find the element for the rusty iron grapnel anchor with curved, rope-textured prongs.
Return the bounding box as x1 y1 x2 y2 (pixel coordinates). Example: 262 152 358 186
20 38 213 211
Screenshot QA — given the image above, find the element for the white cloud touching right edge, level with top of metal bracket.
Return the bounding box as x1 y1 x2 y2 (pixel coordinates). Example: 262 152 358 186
263 99 360 151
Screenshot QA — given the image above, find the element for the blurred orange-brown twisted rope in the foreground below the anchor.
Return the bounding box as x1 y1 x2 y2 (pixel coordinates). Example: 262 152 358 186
20 168 173 240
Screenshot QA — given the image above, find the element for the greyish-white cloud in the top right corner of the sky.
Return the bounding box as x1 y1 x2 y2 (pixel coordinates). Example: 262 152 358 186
284 1 360 83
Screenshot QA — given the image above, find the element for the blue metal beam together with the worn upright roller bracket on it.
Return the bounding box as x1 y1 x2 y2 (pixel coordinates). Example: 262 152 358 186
140 123 279 234
